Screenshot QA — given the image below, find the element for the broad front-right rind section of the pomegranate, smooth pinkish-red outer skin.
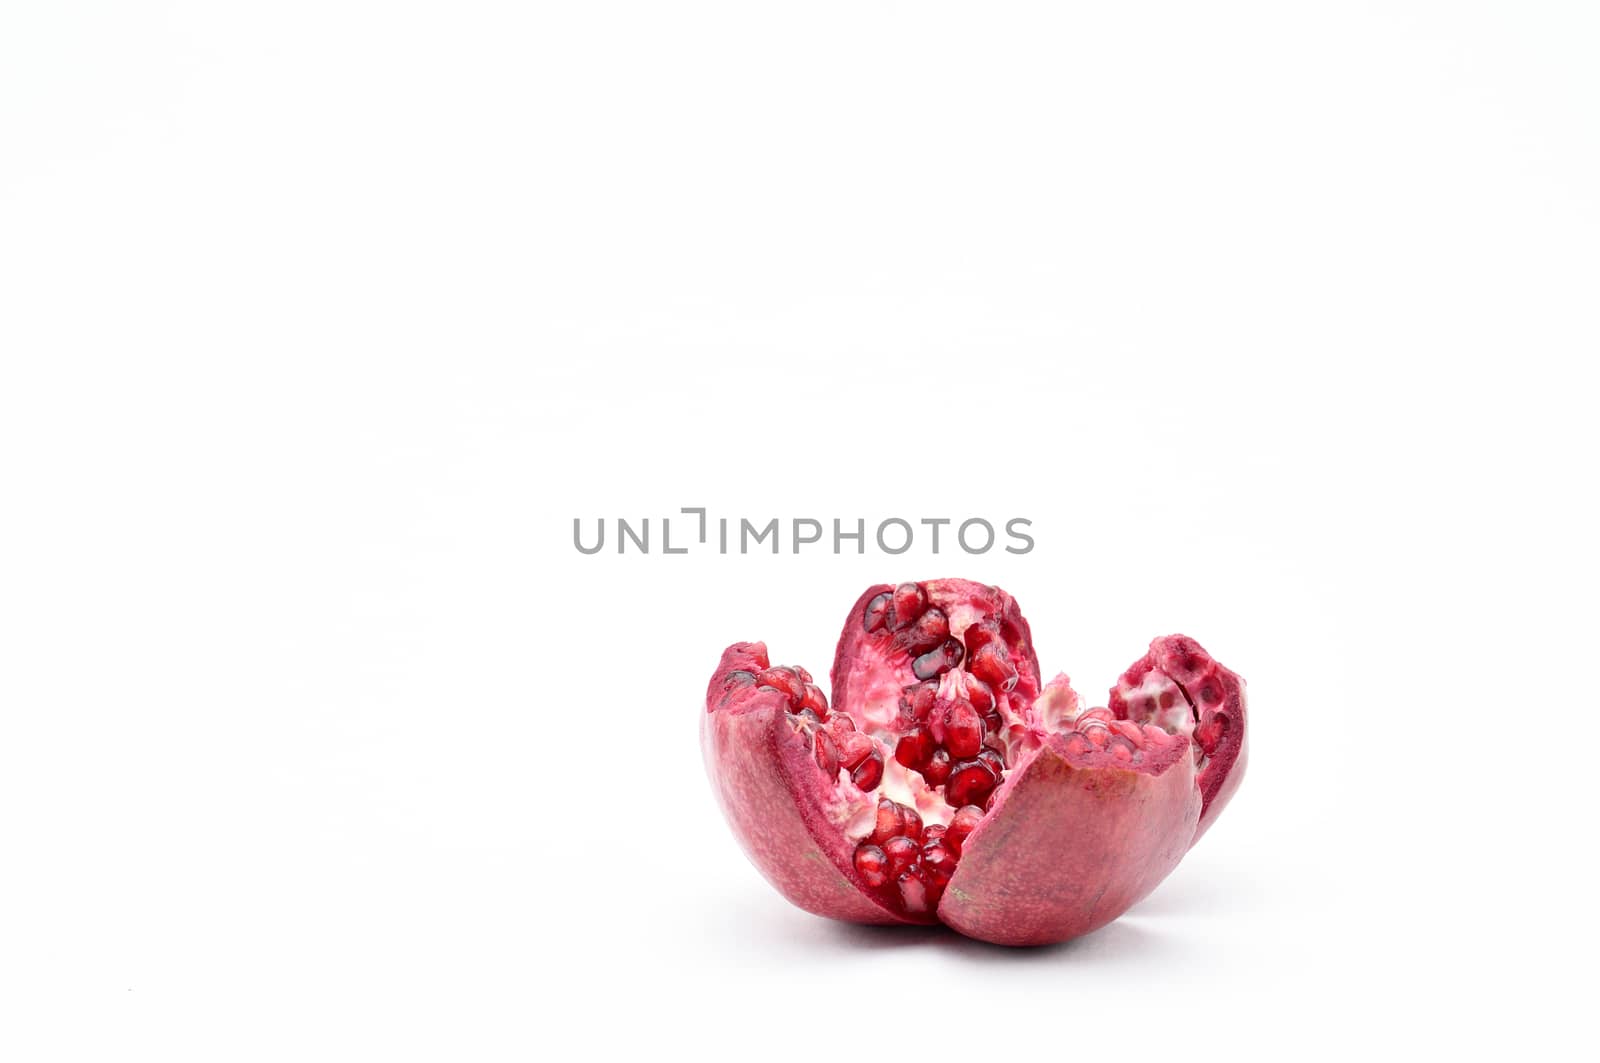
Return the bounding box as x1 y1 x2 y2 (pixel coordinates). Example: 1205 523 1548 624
939 735 1202 945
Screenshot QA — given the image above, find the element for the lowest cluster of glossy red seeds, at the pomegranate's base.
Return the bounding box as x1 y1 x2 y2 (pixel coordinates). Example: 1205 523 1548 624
854 797 984 916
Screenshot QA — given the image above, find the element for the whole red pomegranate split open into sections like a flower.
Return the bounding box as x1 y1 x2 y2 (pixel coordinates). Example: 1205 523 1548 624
701 580 1245 945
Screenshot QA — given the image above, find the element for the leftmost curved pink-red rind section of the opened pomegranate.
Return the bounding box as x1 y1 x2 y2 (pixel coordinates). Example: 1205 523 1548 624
701 642 933 924
